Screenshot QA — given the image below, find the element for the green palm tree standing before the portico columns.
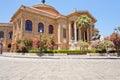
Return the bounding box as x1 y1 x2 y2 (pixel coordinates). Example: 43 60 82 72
77 15 91 40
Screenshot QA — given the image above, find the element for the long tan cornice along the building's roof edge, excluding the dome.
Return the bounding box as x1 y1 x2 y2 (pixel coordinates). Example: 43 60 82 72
10 5 97 23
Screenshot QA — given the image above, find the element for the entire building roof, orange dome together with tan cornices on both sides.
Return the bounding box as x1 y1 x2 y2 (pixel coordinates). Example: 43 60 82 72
10 4 97 22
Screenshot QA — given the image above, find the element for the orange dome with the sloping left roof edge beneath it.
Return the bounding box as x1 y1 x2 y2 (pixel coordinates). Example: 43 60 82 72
10 4 60 22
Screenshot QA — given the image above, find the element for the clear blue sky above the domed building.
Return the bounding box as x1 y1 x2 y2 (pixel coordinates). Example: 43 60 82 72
0 0 120 36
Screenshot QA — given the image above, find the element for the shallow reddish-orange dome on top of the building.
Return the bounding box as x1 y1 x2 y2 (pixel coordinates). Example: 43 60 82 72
32 4 59 16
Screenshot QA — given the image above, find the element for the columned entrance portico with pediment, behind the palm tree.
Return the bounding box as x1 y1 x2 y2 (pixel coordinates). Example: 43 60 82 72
68 11 96 49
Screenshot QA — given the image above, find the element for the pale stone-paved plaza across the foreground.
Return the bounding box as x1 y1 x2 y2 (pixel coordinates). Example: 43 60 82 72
0 53 120 80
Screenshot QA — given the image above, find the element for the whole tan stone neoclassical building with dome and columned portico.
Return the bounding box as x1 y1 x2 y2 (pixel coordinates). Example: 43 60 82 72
0 4 96 49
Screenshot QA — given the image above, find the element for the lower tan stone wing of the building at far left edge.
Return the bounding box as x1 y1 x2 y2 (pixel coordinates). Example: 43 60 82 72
0 22 13 51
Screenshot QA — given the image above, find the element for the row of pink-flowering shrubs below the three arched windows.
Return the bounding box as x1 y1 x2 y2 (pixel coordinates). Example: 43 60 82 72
16 36 56 52
